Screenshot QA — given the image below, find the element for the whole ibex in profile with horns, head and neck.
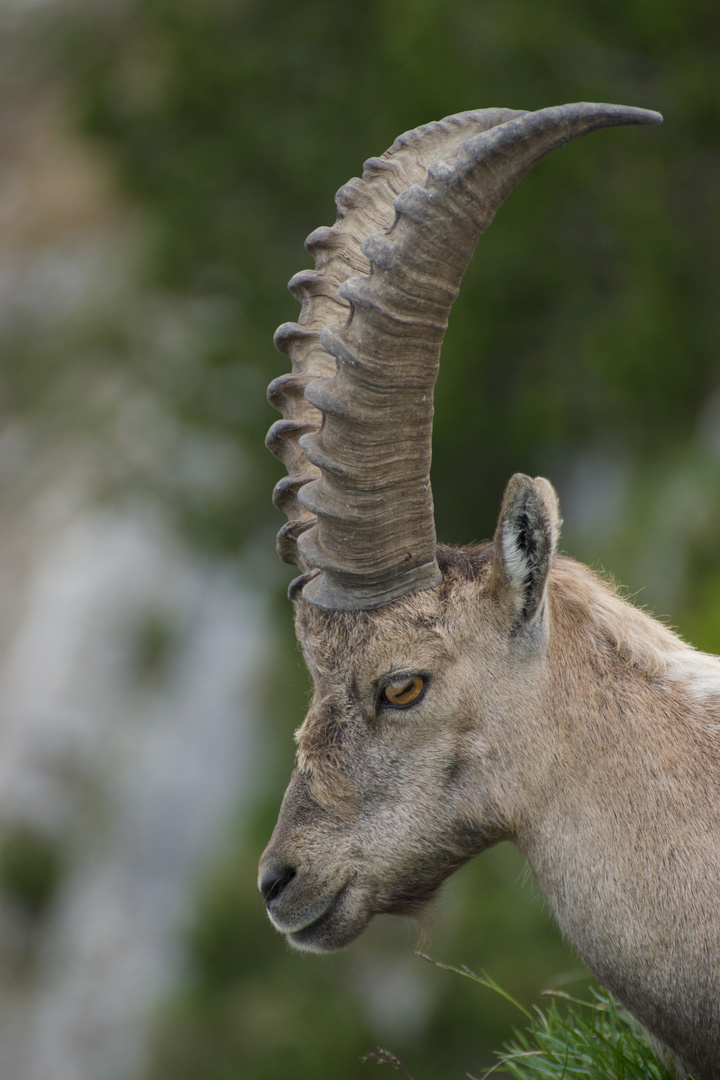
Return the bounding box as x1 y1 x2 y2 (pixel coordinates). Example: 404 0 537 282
255 104 720 1080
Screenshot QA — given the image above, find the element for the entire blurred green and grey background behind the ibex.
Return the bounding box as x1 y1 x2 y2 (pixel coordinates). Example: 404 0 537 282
0 0 720 1080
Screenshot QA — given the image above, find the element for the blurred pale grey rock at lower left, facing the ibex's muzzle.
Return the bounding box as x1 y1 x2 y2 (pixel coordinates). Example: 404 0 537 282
0 510 263 1080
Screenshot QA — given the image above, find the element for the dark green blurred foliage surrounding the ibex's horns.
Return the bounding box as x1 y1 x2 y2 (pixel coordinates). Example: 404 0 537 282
62 0 720 570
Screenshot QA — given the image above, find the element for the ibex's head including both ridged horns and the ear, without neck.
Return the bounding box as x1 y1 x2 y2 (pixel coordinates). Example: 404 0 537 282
260 104 669 950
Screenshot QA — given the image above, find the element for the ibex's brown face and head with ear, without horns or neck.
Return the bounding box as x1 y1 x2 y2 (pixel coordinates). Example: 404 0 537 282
261 476 558 950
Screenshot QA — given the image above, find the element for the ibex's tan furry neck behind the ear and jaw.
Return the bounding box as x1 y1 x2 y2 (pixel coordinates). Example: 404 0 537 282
507 561 720 1053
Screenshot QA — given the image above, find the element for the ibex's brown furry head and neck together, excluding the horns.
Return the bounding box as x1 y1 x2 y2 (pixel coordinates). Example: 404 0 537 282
261 477 720 1080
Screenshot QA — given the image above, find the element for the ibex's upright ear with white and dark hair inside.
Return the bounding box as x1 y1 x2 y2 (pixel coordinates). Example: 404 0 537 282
492 473 561 632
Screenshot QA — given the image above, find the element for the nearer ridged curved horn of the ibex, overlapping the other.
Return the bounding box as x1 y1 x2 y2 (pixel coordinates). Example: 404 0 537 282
271 104 662 609
